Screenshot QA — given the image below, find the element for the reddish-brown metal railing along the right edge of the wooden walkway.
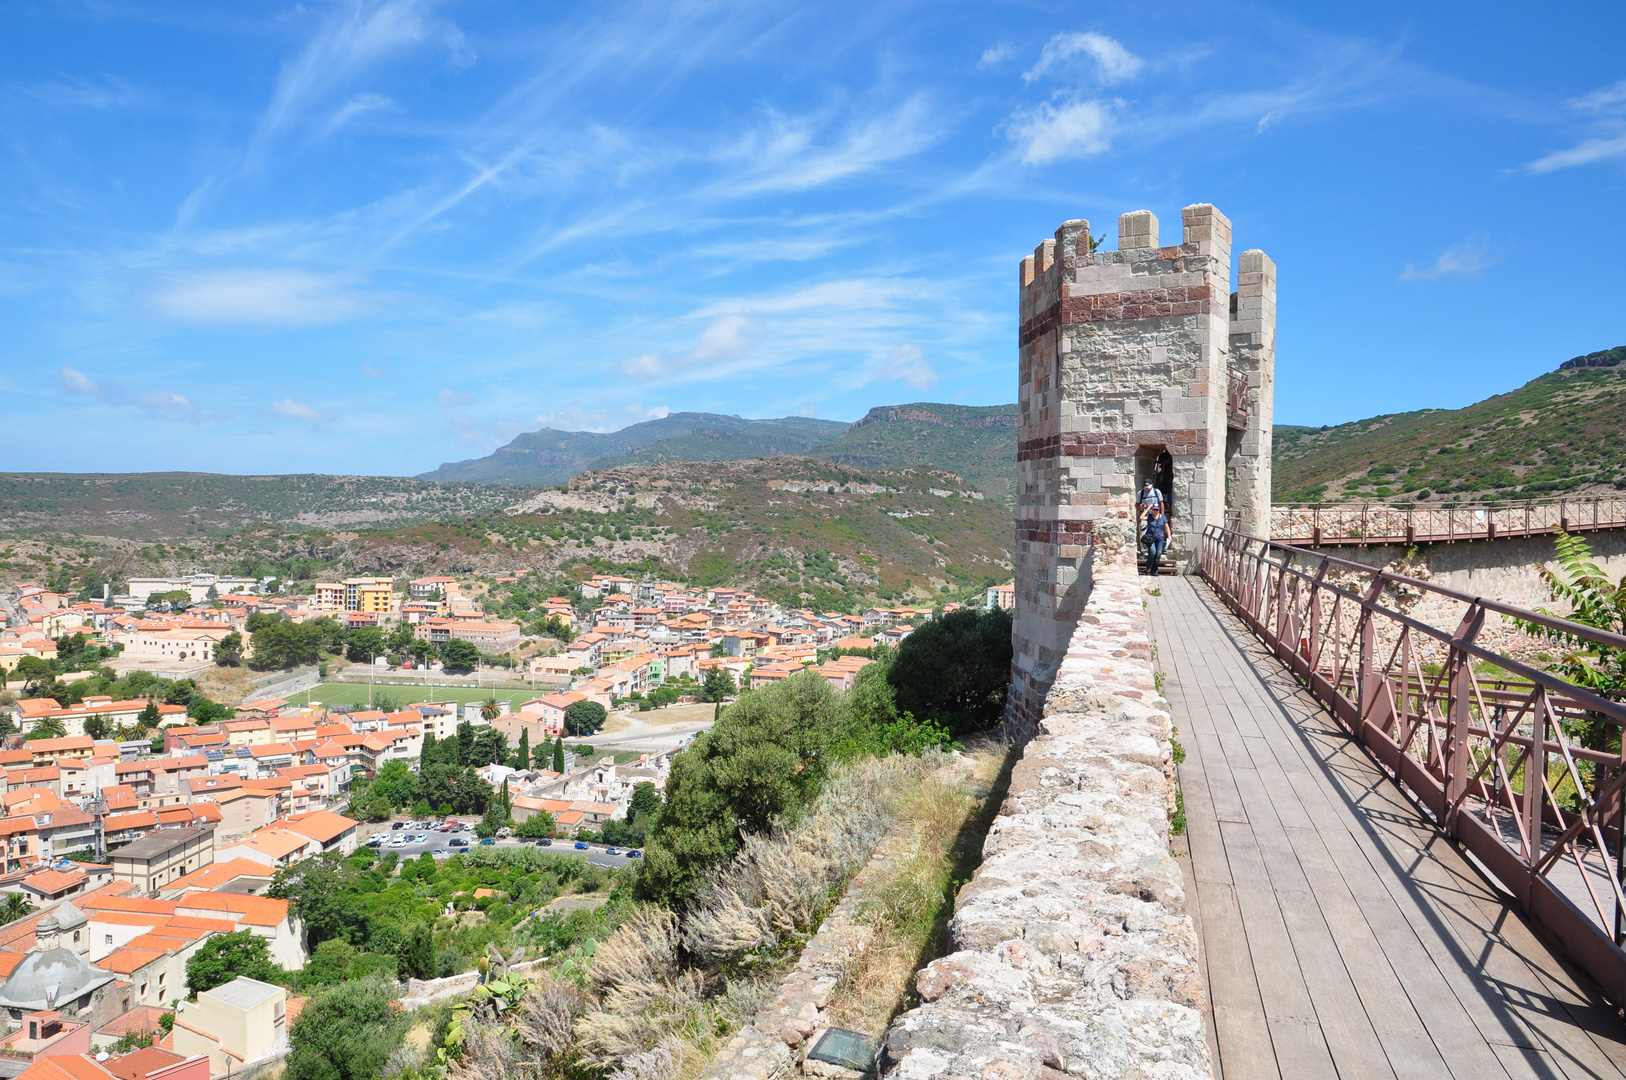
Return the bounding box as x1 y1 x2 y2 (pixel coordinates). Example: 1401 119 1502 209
1202 525 1626 1005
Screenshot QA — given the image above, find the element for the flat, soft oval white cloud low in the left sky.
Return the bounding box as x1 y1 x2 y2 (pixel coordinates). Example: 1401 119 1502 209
150 268 366 327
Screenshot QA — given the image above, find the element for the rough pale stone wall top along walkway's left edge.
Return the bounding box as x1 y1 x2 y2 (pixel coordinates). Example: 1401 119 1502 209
883 545 1211 1080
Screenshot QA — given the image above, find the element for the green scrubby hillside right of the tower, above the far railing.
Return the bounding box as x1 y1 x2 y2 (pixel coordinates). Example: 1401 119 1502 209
1273 346 1626 503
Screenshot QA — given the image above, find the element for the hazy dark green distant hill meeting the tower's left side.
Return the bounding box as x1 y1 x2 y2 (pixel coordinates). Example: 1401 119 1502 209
813 402 1016 506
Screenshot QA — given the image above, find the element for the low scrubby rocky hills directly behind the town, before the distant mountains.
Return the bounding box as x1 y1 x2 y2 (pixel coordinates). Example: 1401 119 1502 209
0 455 1013 610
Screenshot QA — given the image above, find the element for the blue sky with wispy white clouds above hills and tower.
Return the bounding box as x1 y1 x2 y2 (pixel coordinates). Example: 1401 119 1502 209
0 0 1626 473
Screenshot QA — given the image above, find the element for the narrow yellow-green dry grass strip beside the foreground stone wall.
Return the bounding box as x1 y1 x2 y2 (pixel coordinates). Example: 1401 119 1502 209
829 742 1010 1036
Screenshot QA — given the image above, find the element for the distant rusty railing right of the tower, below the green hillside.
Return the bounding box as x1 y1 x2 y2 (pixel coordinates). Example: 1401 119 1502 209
1270 494 1626 547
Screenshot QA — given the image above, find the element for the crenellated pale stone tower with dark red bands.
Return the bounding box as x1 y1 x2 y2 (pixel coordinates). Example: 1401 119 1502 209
1006 205 1276 740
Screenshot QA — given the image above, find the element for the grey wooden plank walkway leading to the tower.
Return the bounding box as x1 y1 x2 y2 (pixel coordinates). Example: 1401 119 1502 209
1146 577 1626 1080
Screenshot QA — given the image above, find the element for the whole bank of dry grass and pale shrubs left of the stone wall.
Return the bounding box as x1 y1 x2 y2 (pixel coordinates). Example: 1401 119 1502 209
447 748 1003 1080
